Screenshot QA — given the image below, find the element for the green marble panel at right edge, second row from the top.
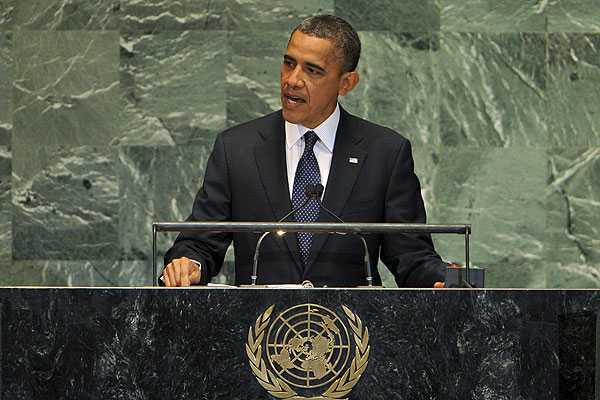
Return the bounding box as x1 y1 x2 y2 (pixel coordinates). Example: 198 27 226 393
546 33 600 146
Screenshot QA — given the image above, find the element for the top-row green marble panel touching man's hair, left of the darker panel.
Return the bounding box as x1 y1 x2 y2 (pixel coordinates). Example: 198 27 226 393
226 0 334 34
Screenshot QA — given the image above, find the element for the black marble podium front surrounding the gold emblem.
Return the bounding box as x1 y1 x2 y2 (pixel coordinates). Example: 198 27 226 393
0 288 600 400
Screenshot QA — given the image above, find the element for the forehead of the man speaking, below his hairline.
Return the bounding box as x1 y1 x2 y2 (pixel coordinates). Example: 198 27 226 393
285 31 337 64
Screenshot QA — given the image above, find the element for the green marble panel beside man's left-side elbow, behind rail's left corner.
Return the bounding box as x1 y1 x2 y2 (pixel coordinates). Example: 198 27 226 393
119 145 212 260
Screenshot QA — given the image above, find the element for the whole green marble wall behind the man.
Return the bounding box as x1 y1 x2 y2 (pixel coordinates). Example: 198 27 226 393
0 0 600 288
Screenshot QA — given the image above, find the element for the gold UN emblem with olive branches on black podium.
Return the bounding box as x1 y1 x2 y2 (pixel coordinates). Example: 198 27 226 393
246 303 371 400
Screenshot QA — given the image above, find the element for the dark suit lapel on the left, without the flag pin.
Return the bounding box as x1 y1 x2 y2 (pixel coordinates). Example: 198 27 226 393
254 112 303 271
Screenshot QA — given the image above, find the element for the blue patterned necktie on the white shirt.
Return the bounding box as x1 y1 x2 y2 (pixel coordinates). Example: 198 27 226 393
292 131 321 265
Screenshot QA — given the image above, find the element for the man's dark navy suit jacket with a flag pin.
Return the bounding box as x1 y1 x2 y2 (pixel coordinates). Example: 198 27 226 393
165 109 445 287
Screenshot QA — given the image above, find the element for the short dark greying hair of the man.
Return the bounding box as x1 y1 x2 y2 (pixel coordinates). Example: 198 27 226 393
290 15 361 72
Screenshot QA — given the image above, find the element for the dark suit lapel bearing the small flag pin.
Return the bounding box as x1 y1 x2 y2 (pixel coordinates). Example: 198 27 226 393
306 107 367 269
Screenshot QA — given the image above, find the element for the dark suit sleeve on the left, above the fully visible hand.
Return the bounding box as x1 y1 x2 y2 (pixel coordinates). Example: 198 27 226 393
164 135 232 285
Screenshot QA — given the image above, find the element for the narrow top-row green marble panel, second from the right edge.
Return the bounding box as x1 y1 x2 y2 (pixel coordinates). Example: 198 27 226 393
440 0 548 32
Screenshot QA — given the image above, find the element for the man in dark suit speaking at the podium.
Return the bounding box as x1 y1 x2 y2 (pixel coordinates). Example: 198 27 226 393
162 15 446 287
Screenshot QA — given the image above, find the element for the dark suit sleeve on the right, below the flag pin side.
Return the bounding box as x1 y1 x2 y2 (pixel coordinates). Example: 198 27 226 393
381 140 446 287
